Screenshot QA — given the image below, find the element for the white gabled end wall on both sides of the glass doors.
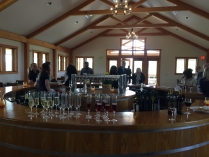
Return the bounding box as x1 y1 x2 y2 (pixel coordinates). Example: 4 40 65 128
73 36 206 87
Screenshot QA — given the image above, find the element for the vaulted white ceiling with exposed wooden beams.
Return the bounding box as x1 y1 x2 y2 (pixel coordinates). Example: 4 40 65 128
0 0 209 51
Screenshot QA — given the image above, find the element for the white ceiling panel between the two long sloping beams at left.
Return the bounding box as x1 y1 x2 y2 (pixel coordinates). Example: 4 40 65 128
35 15 103 43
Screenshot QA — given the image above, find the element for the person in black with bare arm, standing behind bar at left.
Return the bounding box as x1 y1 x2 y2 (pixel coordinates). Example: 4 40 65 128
39 63 52 92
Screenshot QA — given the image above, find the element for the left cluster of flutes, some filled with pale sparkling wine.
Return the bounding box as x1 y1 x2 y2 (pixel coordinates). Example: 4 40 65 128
26 91 81 120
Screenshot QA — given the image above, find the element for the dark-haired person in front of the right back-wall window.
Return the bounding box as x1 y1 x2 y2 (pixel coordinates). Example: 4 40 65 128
181 69 197 89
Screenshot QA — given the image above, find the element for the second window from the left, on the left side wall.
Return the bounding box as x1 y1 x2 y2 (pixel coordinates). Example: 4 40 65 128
33 50 49 67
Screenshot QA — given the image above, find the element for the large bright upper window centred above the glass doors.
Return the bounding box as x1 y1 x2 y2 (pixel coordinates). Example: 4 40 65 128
121 39 145 56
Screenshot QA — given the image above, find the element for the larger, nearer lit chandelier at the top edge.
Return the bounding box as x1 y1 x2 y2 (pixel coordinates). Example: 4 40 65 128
110 0 132 15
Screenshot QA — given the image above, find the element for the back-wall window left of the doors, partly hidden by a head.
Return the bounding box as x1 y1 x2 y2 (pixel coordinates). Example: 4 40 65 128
76 57 94 71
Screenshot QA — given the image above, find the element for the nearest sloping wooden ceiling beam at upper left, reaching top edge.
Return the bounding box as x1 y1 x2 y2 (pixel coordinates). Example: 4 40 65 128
27 0 95 38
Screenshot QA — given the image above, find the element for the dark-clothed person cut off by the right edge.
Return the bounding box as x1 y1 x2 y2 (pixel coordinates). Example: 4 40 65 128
200 67 209 97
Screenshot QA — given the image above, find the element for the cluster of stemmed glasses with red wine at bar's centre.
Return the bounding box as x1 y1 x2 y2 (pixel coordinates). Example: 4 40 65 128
86 93 117 122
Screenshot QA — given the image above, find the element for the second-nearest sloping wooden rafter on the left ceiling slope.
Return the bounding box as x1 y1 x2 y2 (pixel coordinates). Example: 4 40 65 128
55 15 110 45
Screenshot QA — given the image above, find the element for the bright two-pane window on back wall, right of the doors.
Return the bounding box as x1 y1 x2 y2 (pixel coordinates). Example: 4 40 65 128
175 57 198 74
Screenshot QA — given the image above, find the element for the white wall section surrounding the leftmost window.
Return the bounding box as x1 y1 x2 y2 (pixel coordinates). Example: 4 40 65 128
0 38 24 83
